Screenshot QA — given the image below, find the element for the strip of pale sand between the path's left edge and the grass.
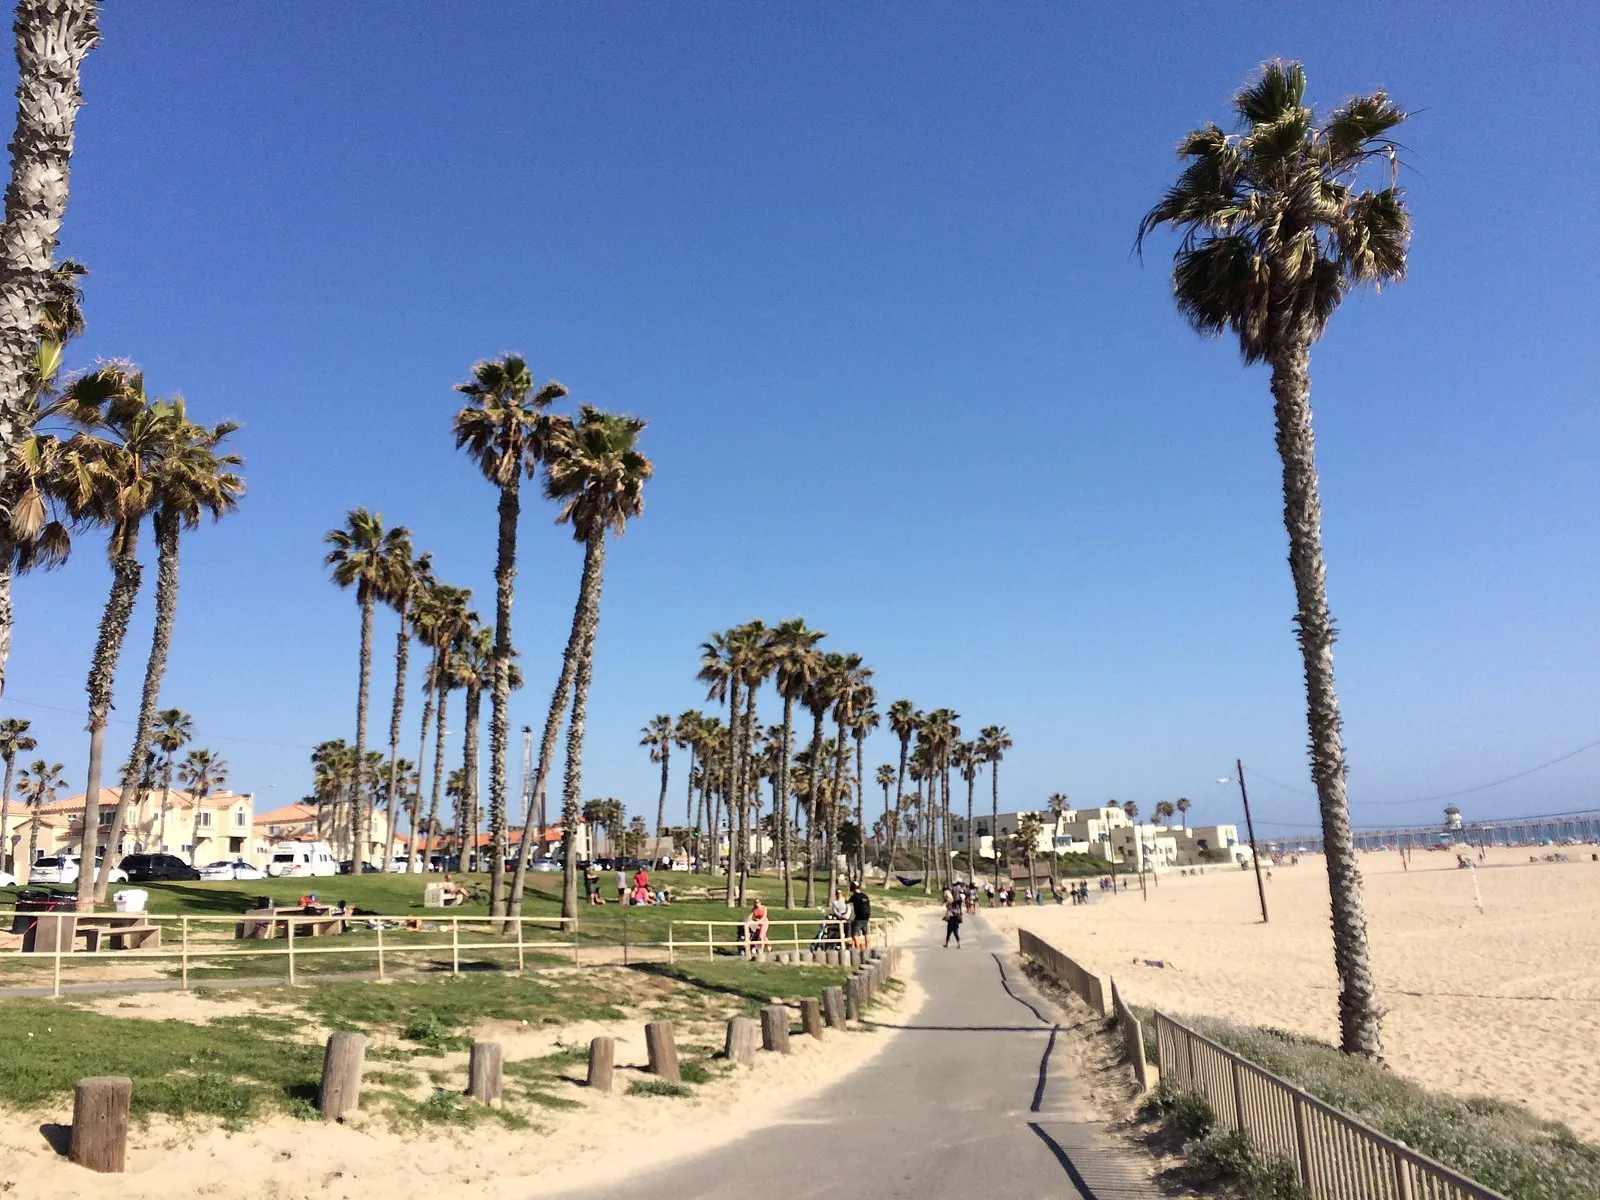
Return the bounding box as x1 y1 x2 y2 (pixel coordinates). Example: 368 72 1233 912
0 955 923 1200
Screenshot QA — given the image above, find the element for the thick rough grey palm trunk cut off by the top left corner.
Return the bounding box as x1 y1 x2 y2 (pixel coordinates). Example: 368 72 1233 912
0 0 99 649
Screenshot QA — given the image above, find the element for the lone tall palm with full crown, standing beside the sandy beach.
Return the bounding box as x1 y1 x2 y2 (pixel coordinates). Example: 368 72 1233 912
1136 61 1411 1058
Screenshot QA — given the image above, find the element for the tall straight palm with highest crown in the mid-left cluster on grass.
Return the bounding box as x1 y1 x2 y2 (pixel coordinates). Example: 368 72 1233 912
454 354 566 915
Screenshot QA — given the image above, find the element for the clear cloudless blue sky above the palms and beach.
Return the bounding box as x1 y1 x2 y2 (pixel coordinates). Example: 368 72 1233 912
5 2 1600 827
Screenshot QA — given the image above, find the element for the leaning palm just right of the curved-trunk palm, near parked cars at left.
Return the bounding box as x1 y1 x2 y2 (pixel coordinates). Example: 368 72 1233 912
94 395 245 901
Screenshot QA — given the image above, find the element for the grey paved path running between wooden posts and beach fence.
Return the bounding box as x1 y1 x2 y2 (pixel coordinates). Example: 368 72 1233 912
544 917 1160 1200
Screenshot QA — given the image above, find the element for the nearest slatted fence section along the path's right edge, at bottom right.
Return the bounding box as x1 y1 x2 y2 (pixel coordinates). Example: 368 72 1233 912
1155 1013 1506 1200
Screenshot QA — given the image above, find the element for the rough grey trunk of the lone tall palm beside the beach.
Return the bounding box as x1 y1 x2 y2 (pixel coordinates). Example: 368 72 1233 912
1272 339 1382 1058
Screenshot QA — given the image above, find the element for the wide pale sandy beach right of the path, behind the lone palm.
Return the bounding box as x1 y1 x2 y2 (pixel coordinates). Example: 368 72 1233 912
987 846 1600 1141
